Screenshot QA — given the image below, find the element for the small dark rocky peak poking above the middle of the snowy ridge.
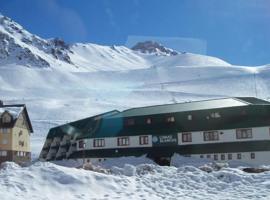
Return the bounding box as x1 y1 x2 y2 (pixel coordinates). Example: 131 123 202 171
131 41 179 56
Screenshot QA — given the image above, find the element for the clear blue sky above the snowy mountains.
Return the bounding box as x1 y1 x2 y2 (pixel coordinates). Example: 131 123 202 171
0 0 270 65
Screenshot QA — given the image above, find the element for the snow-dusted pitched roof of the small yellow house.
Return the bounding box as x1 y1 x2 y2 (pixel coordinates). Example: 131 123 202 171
0 104 33 133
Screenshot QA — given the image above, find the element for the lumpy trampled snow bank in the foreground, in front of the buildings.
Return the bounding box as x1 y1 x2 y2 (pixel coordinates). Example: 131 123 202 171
0 158 270 200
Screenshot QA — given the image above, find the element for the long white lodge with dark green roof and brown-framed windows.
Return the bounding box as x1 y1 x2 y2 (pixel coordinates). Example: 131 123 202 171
40 97 270 165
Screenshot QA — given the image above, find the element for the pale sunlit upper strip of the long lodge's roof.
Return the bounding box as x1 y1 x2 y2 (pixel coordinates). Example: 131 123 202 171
111 98 253 118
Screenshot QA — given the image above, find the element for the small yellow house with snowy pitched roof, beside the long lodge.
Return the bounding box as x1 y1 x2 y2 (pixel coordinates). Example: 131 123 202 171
0 101 33 164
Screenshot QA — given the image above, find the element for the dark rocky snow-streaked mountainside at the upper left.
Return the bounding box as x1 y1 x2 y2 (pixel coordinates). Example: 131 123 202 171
0 15 72 68
